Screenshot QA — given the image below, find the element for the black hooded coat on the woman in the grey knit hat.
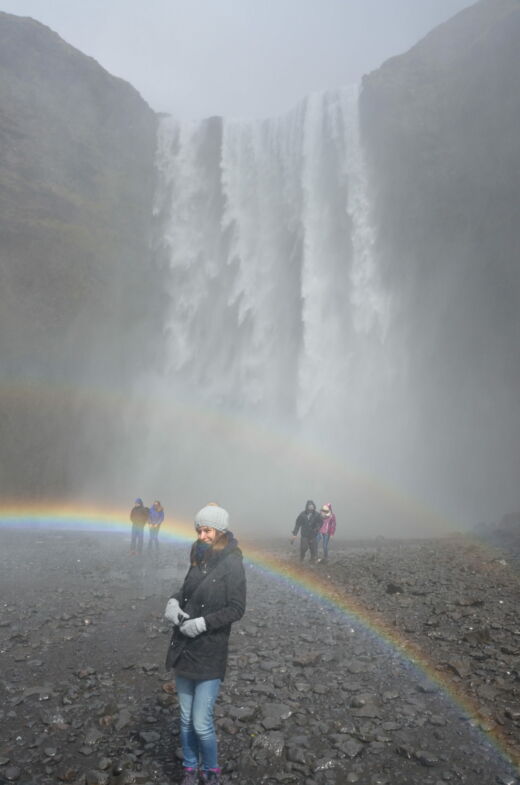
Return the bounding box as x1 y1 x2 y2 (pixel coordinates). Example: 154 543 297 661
166 532 246 679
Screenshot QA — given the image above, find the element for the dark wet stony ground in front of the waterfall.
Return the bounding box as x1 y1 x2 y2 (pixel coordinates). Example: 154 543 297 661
0 530 520 785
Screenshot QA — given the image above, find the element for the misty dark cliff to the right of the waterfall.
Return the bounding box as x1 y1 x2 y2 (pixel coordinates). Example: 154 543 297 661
361 0 520 510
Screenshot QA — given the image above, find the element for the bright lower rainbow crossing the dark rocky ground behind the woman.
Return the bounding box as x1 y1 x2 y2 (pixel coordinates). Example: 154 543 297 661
0 501 520 770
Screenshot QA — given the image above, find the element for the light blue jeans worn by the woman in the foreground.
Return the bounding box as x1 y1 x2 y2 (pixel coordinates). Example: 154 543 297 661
175 676 220 771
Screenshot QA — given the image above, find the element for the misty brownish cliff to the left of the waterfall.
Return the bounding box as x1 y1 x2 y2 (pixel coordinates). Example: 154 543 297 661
0 13 158 495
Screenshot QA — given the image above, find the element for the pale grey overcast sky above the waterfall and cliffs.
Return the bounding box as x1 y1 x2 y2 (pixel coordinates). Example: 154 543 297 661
0 0 472 118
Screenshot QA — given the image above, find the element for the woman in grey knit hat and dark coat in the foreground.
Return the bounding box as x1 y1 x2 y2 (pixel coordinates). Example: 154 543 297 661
165 504 246 785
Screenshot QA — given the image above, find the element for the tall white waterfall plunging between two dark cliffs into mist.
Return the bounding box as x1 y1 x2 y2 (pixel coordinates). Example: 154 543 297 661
149 88 462 530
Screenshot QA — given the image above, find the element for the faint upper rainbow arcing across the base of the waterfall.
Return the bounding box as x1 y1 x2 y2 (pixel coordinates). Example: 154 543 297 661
0 376 460 536
